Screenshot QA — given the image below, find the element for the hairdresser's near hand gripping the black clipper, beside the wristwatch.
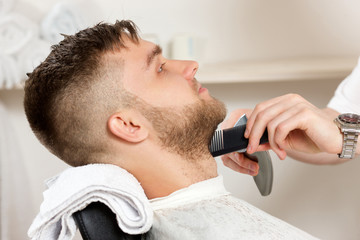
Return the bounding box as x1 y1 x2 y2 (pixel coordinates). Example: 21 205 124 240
245 94 342 159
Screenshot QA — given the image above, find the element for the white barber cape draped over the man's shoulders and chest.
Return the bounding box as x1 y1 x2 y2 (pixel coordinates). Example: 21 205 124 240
147 176 316 240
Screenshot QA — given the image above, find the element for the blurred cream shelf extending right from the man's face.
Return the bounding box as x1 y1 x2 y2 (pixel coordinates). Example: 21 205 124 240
197 57 358 84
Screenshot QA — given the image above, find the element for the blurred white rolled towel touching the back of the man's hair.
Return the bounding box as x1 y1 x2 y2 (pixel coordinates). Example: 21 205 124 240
17 39 51 79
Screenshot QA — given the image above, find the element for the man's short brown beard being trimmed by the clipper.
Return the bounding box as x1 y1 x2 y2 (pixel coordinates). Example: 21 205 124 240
137 98 226 161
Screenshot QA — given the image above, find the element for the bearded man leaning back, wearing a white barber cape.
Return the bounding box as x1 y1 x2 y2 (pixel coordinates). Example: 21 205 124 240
24 21 313 239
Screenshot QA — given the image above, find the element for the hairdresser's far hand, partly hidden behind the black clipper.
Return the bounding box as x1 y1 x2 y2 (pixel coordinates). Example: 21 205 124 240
221 109 269 176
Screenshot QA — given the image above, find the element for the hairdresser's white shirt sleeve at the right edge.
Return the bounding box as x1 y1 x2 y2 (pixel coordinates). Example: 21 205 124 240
327 58 360 114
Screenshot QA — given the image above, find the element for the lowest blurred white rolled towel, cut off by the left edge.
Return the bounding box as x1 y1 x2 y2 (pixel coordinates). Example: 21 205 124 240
0 52 22 89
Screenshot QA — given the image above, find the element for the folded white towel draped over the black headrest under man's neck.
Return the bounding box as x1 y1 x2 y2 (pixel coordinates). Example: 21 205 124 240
28 164 153 240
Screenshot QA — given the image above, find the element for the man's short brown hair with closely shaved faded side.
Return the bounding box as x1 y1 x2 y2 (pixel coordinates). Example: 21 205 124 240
24 20 139 166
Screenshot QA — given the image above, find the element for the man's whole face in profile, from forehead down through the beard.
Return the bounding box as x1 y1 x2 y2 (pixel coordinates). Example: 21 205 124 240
114 37 226 160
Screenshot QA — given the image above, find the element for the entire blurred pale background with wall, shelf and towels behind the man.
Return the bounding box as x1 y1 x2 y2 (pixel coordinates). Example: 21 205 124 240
0 0 360 240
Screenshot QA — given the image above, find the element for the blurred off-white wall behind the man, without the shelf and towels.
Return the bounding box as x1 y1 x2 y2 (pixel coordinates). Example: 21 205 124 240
0 0 360 239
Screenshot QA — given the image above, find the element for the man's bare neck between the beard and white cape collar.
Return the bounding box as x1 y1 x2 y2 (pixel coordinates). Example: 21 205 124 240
124 145 218 199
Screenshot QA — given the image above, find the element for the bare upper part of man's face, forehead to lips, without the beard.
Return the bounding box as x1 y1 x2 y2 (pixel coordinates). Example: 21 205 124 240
121 39 211 107
